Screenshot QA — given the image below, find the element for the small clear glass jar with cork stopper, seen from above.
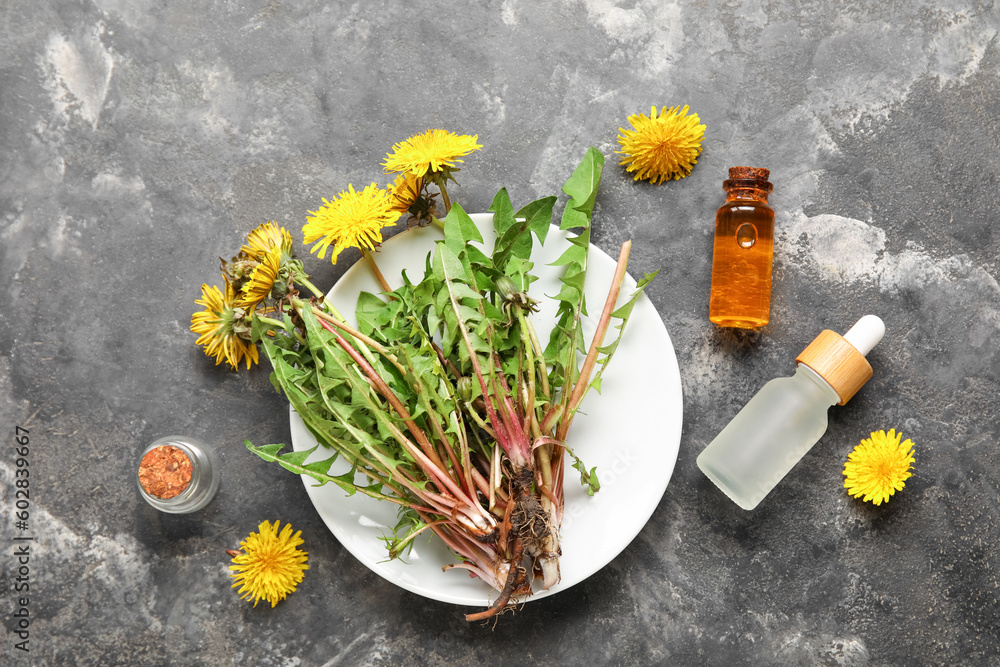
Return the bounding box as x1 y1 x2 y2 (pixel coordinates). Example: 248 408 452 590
136 435 220 514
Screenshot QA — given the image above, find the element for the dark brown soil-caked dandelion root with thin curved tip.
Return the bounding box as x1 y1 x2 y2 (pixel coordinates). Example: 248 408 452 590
465 466 552 621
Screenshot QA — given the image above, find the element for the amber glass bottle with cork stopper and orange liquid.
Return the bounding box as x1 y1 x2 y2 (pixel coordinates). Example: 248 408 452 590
708 167 774 329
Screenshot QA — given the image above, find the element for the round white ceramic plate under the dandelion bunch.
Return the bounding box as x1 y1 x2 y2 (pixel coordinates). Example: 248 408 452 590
291 214 683 607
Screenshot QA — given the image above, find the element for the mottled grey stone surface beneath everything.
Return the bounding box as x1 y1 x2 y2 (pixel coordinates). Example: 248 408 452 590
0 0 1000 666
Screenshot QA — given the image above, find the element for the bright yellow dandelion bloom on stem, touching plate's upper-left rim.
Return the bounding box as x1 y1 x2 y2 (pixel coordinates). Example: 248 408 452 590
302 183 401 264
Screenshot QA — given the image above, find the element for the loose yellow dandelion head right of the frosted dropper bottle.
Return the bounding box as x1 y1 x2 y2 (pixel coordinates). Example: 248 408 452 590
844 429 914 505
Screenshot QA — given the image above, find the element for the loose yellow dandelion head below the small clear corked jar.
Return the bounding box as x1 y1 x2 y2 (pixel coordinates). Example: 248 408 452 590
229 521 309 608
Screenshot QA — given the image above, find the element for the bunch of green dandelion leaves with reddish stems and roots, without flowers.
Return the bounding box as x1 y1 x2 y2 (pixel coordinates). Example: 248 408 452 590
204 142 655 620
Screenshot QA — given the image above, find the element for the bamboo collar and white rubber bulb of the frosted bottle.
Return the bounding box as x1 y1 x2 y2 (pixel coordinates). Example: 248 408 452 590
795 315 885 405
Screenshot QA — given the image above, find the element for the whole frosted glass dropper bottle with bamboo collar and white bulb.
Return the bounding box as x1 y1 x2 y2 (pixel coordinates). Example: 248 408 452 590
698 315 885 510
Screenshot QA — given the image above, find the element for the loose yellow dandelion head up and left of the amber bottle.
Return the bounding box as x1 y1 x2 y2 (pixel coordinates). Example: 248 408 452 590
616 106 705 185
